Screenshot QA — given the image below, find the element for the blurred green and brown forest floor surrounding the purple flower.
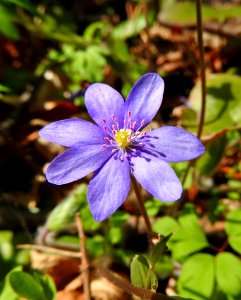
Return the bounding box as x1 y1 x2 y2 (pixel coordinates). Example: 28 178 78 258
0 0 241 300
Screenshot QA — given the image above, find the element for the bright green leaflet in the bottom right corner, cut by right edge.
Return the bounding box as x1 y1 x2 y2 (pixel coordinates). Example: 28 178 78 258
216 252 241 297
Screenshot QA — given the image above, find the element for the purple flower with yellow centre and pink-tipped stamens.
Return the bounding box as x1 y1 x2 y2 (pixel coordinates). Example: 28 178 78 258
40 73 205 221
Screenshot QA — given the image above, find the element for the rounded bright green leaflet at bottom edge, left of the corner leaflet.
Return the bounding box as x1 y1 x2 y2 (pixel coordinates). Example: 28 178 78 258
177 253 215 300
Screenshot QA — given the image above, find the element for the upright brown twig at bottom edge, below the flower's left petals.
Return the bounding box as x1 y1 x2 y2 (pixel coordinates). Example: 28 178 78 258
75 213 91 300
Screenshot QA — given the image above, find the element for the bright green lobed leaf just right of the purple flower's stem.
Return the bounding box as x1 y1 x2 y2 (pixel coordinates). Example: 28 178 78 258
153 214 209 260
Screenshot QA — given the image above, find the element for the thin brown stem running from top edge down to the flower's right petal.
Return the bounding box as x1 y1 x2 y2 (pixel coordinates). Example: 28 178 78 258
196 0 206 138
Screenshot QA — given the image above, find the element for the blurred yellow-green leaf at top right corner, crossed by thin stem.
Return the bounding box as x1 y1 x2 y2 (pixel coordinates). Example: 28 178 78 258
159 1 241 24
